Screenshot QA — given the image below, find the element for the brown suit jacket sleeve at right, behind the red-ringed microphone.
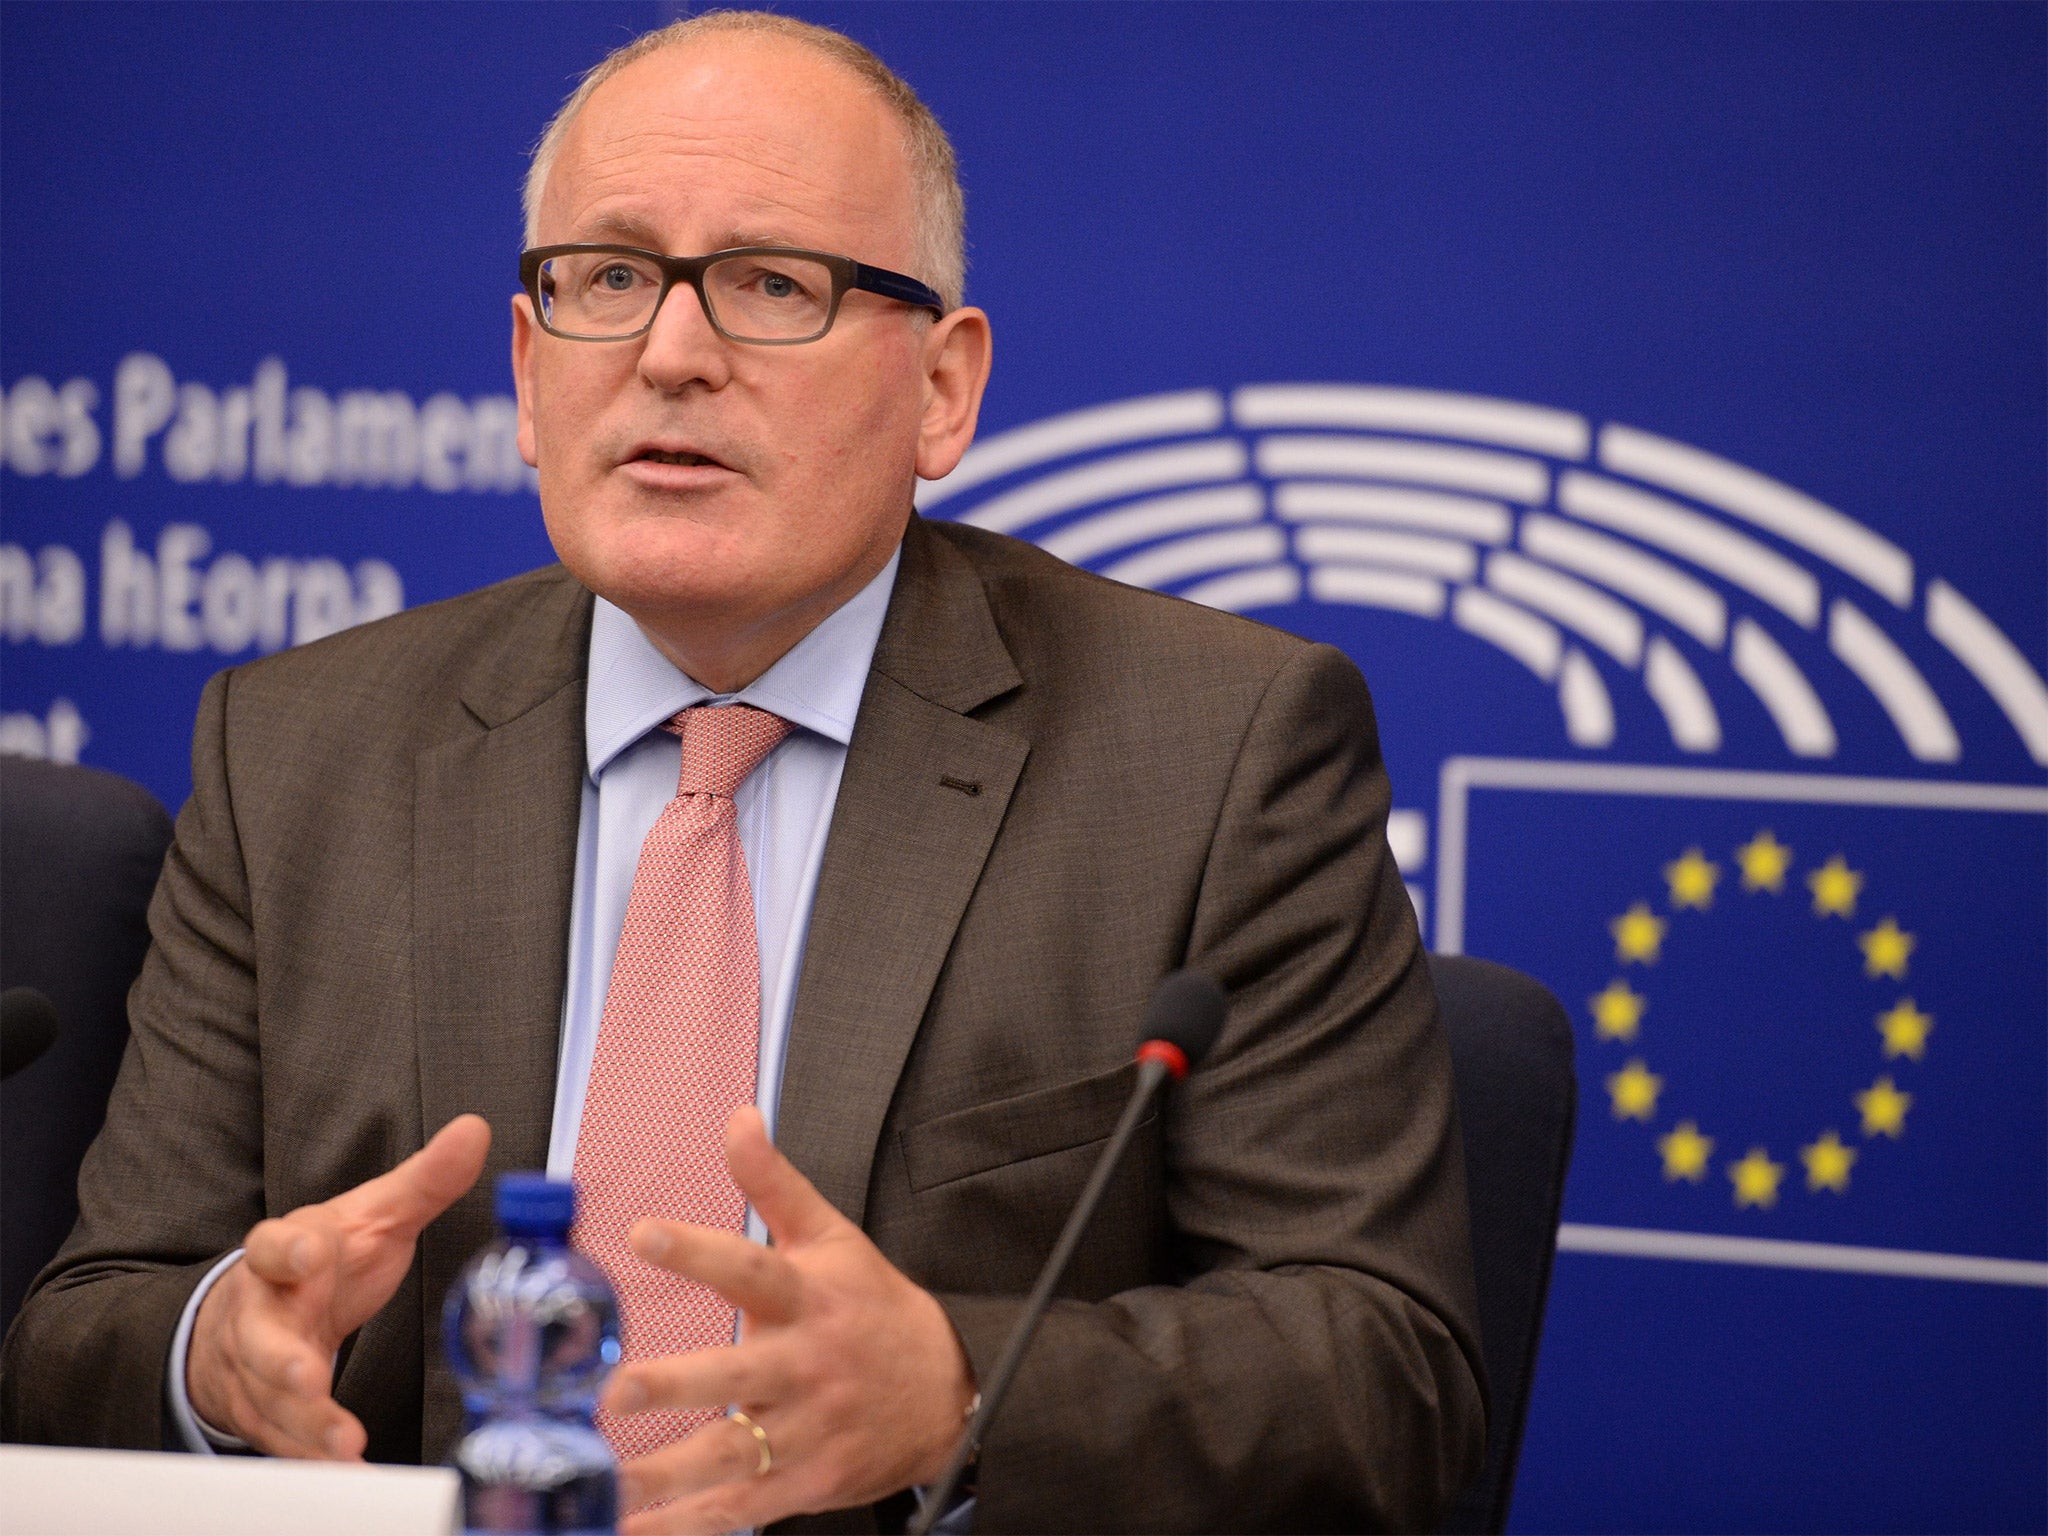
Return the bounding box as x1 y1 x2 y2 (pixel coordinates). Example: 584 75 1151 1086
940 647 1485 1532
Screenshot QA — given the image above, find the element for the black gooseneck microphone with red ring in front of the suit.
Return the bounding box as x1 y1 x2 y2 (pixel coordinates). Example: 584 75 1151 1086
909 971 1227 1536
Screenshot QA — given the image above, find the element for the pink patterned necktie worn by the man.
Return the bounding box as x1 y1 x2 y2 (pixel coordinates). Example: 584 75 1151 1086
573 705 793 1460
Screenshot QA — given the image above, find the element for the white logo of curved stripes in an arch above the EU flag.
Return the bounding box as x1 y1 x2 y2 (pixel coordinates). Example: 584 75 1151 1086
920 383 2048 766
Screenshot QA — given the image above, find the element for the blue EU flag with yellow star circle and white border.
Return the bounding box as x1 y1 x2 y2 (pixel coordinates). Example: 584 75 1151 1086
1440 760 2048 1262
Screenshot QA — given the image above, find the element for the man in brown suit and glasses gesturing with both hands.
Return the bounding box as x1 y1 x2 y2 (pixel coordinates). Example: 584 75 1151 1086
0 14 1483 1532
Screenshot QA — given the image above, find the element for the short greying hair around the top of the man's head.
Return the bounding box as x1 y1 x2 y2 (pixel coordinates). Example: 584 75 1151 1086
520 10 967 309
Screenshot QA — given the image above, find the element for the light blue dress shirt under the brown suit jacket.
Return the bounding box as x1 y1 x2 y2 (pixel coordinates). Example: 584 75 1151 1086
166 553 901 1454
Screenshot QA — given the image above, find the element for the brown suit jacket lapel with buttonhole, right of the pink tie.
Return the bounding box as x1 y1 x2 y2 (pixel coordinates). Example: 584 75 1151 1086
776 518 1030 1223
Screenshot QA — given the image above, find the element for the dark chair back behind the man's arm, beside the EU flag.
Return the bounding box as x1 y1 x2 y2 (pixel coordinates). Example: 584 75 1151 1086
1430 954 1579 1532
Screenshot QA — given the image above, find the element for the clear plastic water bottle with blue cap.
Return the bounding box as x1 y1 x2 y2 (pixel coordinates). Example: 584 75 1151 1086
442 1174 618 1536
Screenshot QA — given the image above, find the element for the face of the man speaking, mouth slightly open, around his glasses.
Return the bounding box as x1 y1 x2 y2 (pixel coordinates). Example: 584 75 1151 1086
512 35 958 671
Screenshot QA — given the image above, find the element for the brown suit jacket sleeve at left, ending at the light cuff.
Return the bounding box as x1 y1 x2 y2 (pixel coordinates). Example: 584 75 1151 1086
0 674 264 1450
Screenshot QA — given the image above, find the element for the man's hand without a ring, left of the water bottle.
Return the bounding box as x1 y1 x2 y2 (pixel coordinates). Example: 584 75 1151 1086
184 1114 492 1460
